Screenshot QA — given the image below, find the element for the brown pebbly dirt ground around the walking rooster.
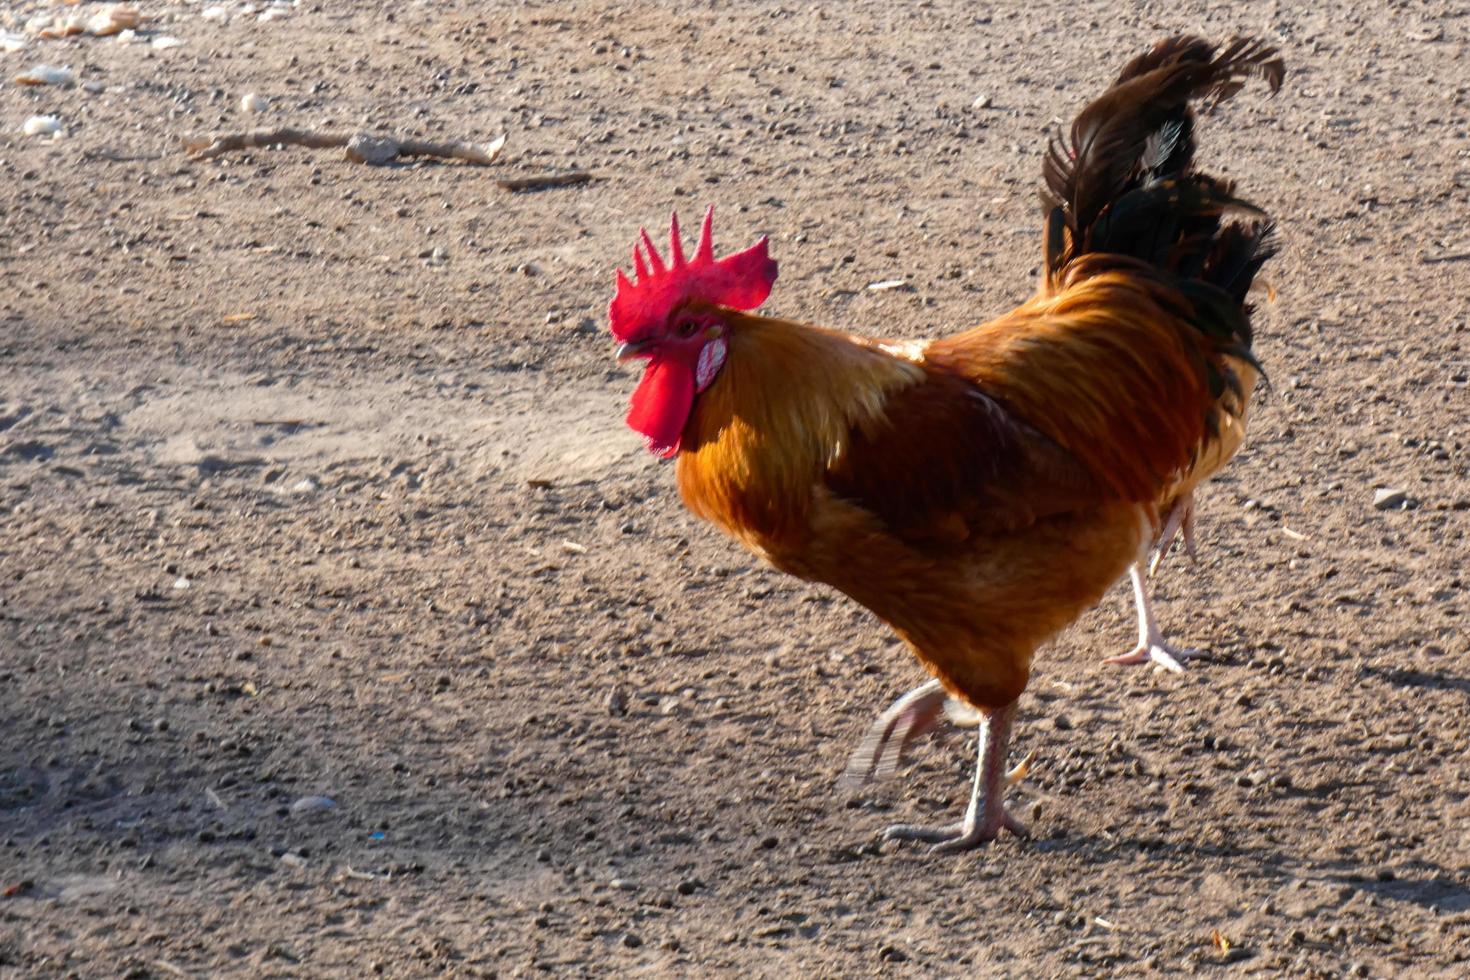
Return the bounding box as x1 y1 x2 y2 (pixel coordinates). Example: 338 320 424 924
0 0 1470 977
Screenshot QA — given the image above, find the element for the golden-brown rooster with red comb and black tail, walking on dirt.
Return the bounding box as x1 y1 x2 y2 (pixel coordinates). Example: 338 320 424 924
609 37 1285 851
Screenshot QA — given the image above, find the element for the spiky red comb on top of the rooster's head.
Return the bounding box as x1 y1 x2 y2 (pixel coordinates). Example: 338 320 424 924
607 204 776 344
